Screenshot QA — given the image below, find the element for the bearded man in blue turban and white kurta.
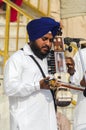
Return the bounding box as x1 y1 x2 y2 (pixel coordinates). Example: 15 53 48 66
4 17 60 130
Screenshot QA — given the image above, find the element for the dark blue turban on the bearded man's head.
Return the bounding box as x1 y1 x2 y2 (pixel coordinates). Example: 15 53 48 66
27 17 60 41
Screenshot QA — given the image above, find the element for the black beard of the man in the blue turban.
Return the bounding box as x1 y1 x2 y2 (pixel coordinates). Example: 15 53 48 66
30 41 50 59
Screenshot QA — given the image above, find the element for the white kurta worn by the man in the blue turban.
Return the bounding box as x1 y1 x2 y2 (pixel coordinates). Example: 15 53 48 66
4 44 57 130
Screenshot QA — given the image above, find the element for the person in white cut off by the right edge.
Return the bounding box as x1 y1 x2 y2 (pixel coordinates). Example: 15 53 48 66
66 48 86 130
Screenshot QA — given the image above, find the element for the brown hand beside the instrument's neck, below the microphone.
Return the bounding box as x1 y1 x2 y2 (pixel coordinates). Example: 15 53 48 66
66 57 75 76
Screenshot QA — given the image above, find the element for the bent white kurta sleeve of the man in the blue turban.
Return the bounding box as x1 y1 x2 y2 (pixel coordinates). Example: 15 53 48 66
4 54 40 96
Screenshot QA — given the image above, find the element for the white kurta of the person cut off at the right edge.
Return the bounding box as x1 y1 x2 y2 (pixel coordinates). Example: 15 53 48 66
71 48 86 130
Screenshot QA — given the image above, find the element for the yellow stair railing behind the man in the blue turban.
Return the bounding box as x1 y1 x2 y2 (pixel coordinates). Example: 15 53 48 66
0 0 50 65
